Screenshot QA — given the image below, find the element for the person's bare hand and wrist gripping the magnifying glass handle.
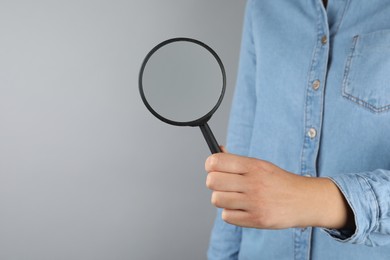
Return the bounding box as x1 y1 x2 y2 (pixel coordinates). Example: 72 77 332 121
205 153 352 229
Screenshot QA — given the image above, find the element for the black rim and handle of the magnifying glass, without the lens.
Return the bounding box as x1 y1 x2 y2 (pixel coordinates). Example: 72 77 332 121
138 37 226 153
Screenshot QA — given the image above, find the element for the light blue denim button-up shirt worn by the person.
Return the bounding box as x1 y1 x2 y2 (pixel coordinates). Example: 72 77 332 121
208 0 390 260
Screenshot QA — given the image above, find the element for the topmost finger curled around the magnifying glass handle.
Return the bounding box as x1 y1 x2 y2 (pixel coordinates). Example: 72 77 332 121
205 153 253 174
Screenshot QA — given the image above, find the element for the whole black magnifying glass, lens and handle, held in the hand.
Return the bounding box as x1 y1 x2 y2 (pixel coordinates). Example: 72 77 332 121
139 38 226 153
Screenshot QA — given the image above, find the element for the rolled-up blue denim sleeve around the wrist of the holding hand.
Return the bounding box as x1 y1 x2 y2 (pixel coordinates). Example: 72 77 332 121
324 169 390 246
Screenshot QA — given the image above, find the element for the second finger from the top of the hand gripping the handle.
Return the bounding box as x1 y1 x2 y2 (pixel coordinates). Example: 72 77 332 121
206 172 247 192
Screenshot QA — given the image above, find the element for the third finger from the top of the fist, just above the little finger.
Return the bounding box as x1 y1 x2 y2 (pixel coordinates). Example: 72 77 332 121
211 191 248 210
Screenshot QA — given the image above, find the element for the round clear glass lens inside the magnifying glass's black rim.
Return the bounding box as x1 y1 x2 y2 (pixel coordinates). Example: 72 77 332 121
142 41 223 122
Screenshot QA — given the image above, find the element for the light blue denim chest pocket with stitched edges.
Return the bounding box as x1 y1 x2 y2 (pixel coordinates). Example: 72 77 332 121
342 30 390 113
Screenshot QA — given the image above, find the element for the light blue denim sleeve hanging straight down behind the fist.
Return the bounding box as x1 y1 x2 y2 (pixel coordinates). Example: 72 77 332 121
208 0 256 260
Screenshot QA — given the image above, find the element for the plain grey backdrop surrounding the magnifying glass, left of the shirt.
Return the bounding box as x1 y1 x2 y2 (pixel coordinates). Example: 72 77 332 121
0 0 245 260
